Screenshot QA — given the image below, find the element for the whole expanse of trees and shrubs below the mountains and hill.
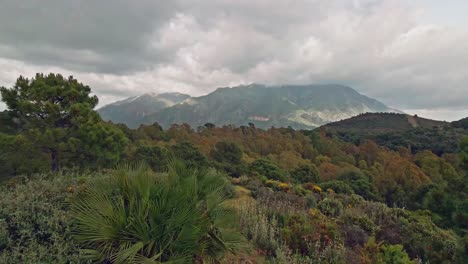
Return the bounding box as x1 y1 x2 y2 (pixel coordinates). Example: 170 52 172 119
0 74 468 264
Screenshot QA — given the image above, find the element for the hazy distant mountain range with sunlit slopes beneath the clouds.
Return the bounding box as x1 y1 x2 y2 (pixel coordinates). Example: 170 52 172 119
99 84 396 129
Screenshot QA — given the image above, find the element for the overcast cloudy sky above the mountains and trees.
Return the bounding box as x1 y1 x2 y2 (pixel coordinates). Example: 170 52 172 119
0 0 468 121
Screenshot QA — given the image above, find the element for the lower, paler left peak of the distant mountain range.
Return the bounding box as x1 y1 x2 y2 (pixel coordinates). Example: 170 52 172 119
97 93 190 127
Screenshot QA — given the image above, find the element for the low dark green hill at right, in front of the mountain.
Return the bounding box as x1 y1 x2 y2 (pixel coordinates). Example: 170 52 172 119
320 113 468 155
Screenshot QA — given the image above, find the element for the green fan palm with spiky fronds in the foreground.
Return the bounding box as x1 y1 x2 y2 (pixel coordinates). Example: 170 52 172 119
72 161 242 263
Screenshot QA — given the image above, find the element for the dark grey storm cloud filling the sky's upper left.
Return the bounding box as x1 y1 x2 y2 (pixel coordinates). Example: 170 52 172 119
0 0 175 73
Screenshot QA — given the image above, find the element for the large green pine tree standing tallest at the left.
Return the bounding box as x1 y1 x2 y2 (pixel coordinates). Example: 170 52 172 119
0 73 126 170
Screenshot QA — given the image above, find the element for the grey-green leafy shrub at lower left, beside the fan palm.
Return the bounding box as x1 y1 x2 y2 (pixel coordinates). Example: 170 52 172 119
0 173 89 264
